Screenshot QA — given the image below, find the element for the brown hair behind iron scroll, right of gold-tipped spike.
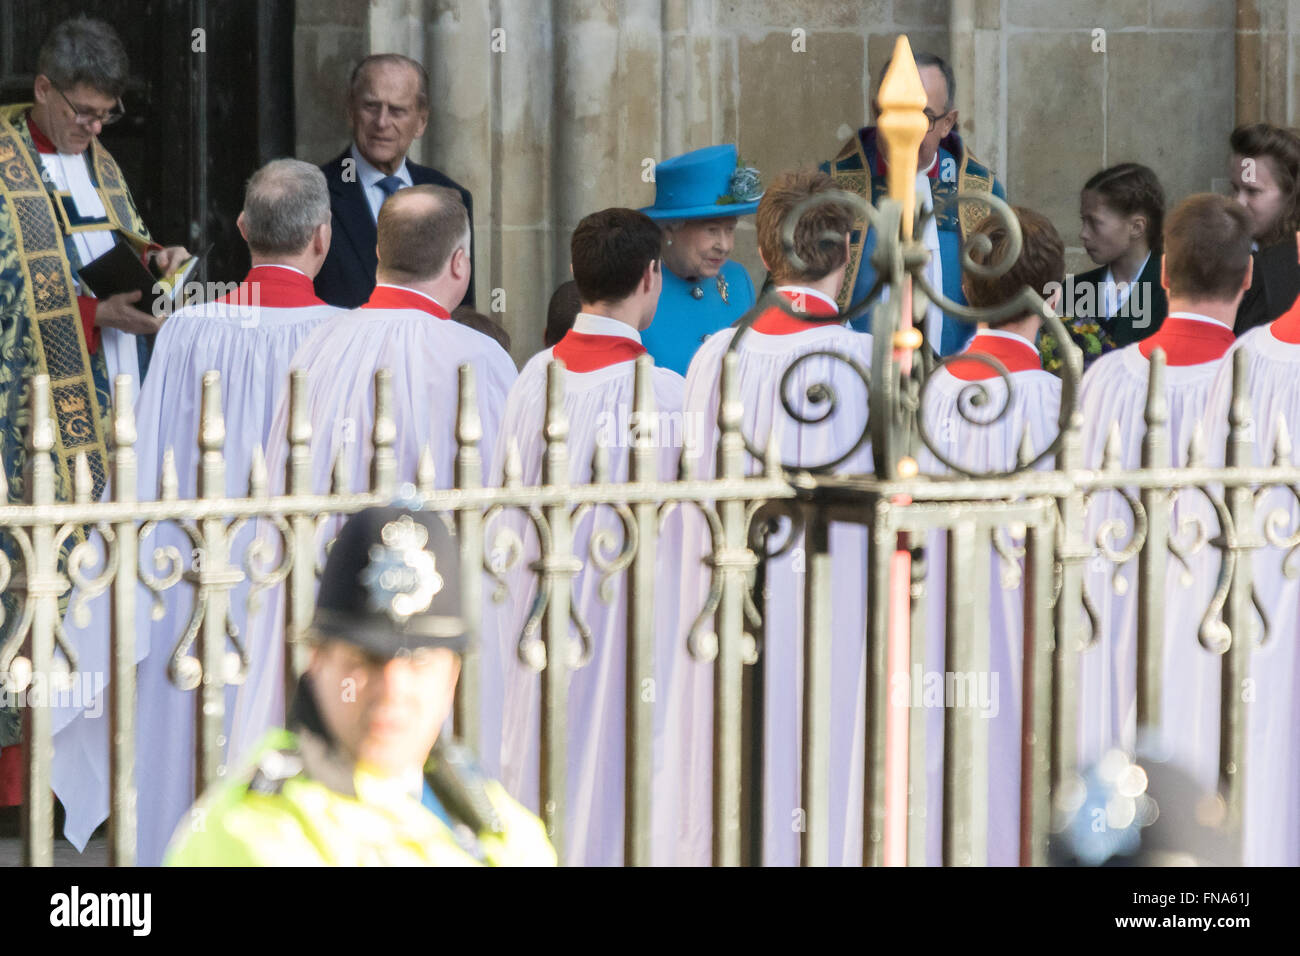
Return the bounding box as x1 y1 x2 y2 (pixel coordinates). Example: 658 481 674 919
963 206 1065 326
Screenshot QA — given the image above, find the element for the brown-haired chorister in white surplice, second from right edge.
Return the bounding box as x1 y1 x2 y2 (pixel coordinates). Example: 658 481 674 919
1079 194 1251 816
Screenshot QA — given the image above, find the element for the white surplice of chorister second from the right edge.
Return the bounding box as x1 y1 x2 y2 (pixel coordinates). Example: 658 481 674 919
1078 332 1222 790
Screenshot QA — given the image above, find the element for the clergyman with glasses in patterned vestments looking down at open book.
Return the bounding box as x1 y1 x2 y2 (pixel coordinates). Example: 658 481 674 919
0 17 190 799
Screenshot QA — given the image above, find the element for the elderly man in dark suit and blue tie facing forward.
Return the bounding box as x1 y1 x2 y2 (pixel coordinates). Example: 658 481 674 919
316 53 475 308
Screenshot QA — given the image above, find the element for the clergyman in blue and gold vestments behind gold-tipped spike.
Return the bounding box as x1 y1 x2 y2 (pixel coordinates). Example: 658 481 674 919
822 51 1006 355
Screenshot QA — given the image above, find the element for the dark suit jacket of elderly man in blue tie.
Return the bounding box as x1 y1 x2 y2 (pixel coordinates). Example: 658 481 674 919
316 147 475 308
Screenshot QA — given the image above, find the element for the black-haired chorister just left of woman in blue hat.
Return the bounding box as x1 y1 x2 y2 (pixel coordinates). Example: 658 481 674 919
484 208 697 866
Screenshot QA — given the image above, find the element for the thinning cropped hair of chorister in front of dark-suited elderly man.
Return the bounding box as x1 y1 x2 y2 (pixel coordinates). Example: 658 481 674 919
378 186 469 282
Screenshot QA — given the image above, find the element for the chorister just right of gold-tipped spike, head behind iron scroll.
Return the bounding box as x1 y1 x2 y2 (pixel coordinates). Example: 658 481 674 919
913 207 1065 866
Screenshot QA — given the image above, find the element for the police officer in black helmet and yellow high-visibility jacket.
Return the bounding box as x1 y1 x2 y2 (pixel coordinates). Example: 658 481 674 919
165 507 555 866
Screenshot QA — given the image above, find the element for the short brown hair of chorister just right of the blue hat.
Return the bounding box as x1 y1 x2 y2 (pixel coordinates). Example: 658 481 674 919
755 169 854 284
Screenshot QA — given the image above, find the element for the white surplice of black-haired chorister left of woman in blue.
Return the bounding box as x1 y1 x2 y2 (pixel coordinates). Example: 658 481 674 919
484 313 699 866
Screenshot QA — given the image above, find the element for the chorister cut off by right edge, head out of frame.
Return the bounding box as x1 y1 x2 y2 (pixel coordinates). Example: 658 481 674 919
1201 231 1300 866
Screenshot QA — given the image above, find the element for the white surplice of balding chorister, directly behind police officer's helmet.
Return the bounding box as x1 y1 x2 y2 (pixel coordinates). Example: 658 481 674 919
228 285 516 773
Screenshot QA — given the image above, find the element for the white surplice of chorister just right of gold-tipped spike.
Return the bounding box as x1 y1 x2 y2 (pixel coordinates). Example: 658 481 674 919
911 329 1061 866
